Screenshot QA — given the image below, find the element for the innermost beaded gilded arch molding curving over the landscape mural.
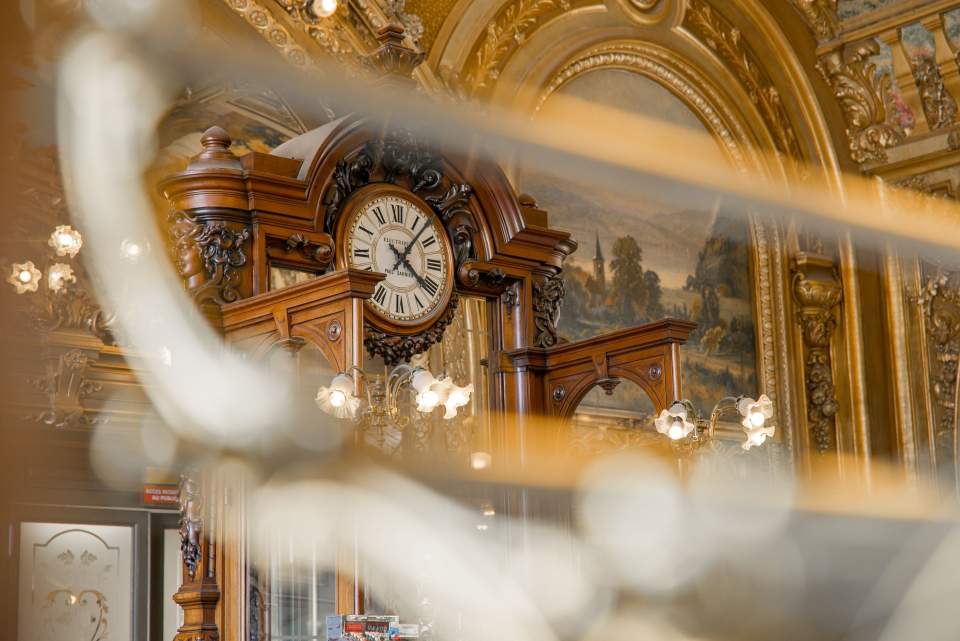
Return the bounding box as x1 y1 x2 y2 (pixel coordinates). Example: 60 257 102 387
534 43 747 167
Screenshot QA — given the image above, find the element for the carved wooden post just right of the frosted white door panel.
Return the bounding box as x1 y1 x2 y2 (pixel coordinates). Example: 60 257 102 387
173 472 220 641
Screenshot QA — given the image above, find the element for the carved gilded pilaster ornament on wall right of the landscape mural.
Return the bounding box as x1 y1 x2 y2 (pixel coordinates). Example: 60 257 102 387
793 252 842 452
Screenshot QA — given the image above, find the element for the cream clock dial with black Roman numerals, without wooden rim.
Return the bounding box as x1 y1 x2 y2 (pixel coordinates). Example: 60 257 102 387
346 195 450 322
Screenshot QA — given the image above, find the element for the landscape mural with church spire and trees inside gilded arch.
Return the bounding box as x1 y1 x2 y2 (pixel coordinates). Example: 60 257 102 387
519 69 757 411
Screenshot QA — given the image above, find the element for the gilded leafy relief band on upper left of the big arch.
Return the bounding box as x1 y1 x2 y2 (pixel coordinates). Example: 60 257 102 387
464 0 571 95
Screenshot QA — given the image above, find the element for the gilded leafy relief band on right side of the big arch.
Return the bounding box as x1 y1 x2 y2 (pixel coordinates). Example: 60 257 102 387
683 0 803 159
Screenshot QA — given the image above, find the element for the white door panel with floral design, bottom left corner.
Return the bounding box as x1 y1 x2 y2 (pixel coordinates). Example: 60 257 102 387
18 523 133 641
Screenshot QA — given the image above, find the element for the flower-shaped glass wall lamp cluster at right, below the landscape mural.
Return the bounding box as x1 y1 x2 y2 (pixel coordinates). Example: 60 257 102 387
654 394 776 450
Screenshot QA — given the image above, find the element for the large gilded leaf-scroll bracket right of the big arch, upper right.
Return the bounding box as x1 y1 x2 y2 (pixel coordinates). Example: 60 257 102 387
817 41 904 163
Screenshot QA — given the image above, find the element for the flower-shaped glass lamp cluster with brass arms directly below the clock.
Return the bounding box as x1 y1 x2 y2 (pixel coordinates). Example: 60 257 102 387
316 364 473 444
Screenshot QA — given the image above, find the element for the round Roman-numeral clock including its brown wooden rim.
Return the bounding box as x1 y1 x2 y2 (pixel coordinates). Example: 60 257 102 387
334 185 454 335
